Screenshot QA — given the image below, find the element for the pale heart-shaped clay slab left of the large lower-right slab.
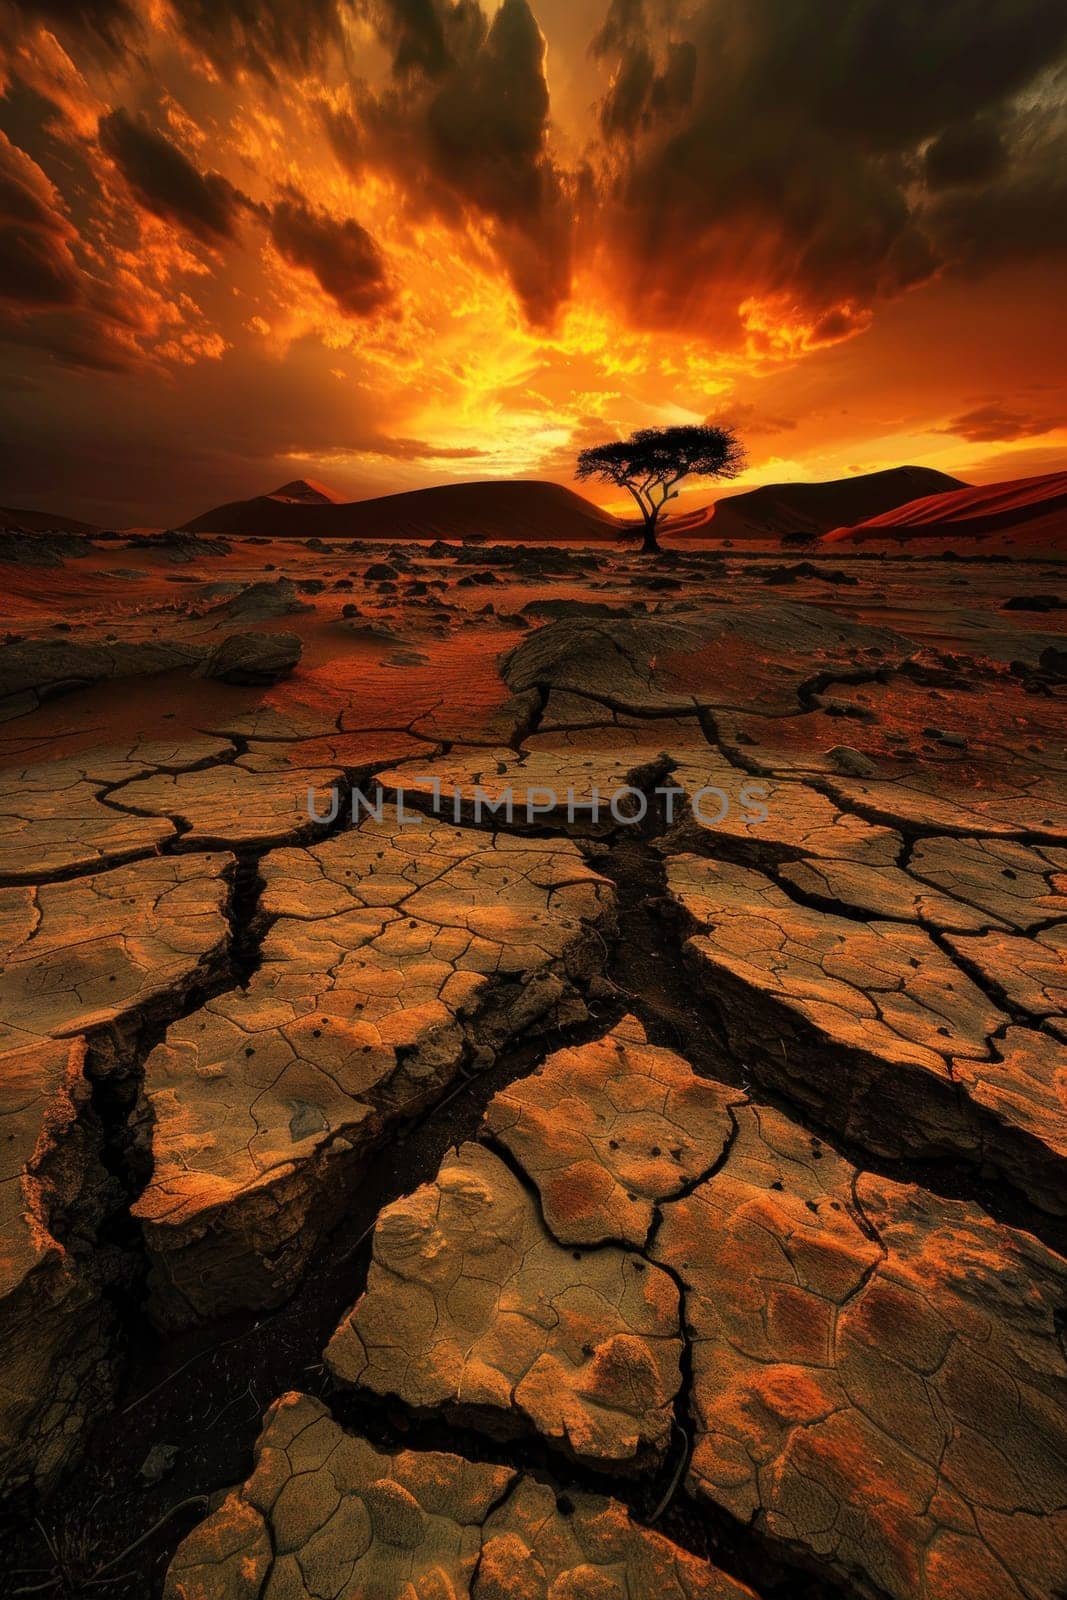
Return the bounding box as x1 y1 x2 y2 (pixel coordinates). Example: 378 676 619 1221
326 1144 681 1472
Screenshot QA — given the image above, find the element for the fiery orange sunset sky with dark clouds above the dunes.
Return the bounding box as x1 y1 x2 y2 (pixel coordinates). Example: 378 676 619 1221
0 0 1067 525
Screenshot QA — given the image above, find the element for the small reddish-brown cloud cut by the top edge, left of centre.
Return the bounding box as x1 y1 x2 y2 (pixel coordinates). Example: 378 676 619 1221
171 0 350 83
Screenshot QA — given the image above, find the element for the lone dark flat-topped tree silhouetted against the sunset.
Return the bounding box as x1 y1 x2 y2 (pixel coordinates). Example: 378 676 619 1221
576 427 745 554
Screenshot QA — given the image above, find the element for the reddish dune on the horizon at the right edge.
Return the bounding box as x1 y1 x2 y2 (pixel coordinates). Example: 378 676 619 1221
822 472 1067 555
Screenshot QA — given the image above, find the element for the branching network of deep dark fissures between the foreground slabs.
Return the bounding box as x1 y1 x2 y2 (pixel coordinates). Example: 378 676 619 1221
4 729 1062 1600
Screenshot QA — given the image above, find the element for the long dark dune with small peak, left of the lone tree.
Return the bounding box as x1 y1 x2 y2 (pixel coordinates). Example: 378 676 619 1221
182 478 627 544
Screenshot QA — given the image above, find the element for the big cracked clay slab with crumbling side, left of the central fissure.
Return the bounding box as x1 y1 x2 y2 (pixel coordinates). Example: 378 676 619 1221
134 818 614 1322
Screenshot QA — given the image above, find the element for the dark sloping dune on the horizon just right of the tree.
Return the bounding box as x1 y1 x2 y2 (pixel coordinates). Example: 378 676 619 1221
664 467 965 539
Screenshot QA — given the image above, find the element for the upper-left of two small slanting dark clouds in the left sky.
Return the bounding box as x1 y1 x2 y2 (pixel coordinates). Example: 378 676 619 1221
99 109 251 245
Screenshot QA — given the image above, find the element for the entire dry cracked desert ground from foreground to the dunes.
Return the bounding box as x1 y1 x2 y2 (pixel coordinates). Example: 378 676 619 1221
0 536 1067 1600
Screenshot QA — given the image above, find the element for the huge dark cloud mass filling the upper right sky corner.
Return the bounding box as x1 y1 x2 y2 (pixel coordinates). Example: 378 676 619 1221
593 0 1067 339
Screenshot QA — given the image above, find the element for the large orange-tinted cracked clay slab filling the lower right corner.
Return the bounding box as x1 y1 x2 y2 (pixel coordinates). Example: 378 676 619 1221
653 1107 1067 1600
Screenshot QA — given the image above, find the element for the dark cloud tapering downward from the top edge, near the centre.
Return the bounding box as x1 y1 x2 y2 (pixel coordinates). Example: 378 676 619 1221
347 0 571 323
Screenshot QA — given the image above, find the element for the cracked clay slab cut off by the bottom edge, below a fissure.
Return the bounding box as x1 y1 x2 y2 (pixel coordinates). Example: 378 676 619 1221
163 1394 755 1600
